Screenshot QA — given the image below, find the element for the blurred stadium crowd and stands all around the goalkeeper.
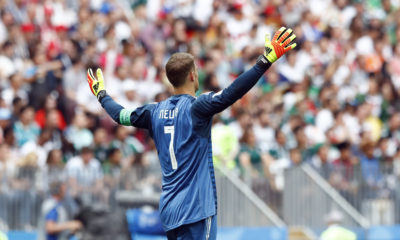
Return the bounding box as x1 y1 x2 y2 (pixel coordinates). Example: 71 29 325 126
0 0 400 240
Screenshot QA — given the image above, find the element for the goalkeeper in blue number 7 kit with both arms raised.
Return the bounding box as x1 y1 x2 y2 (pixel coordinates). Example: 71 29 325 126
87 27 296 240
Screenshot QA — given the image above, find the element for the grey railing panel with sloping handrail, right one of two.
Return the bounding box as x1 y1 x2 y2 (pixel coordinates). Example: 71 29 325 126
283 164 369 228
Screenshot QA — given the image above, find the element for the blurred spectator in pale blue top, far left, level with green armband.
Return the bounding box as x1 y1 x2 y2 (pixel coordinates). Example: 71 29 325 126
14 106 40 147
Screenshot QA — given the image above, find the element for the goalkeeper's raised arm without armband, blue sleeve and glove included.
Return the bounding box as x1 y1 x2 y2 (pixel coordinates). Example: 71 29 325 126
192 27 296 117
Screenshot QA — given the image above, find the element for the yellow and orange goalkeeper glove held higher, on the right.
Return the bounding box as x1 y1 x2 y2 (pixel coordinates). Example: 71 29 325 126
264 27 296 63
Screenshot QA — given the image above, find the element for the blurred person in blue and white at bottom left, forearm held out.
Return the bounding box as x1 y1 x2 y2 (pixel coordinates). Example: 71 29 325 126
38 181 82 240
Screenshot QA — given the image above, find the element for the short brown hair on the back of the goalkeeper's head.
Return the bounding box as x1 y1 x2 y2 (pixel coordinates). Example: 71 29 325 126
165 53 194 87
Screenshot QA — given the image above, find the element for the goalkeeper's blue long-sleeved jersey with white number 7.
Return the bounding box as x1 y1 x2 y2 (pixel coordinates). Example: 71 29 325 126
101 62 267 231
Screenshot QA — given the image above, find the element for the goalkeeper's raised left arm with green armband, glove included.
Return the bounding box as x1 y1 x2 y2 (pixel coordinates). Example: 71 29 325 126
87 68 156 130
